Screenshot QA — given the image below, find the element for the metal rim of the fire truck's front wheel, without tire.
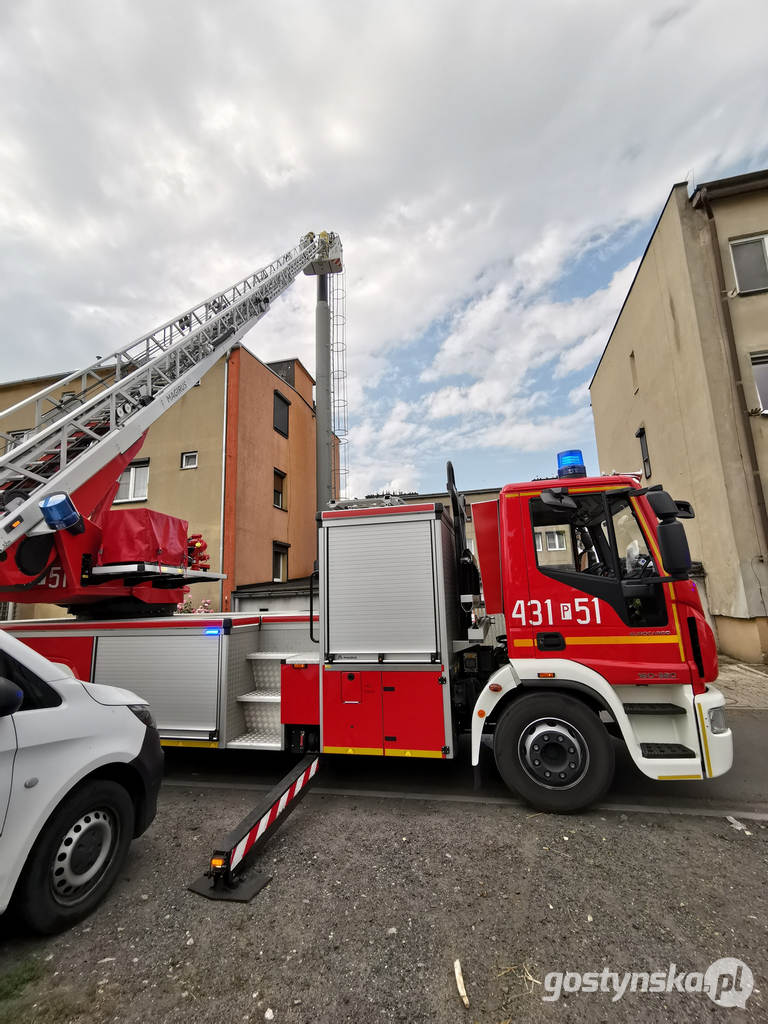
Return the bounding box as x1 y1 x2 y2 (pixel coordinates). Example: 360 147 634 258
517 718 590 790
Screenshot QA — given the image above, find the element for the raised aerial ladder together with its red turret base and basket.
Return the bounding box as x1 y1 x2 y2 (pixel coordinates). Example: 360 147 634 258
0 231 342 615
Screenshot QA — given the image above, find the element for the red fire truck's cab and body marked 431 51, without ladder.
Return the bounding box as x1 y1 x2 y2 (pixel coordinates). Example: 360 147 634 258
1 458 732 811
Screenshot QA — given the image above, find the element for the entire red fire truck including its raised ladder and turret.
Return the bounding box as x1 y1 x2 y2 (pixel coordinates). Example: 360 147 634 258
0 236 732 811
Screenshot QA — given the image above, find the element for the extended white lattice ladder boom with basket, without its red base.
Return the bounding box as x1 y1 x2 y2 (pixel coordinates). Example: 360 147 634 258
0 232 341 552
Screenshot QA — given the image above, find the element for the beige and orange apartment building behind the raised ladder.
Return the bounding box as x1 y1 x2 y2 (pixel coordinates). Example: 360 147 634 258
0 346 316 618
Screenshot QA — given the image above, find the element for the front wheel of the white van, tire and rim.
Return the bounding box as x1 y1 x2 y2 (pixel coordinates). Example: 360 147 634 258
13 779 134 935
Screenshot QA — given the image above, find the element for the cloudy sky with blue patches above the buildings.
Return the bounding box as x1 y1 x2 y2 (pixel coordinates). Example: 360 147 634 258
0 0 768 496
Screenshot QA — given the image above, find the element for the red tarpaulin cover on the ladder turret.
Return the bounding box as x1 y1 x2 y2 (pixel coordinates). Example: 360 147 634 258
98 509 189 565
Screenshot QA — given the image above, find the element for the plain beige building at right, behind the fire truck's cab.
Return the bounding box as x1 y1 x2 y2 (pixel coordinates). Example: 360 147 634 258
590 171 768 662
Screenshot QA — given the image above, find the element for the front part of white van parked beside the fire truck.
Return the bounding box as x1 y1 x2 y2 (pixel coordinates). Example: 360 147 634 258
0 630 163 933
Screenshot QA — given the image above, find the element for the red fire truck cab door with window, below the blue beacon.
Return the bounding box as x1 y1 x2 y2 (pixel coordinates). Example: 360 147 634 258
526 487 690 685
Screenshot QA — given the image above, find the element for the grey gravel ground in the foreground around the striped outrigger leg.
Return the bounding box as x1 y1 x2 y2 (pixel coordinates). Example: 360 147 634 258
0 788 768 1024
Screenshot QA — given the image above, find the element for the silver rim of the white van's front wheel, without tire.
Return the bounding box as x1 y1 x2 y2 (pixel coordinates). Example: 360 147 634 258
50 808 120 906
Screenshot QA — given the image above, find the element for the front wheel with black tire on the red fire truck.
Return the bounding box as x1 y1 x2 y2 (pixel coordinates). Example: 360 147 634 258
494 693 614 814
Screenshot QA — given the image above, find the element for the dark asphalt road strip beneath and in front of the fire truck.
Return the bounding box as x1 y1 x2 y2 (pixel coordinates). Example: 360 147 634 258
166 710 768 814
